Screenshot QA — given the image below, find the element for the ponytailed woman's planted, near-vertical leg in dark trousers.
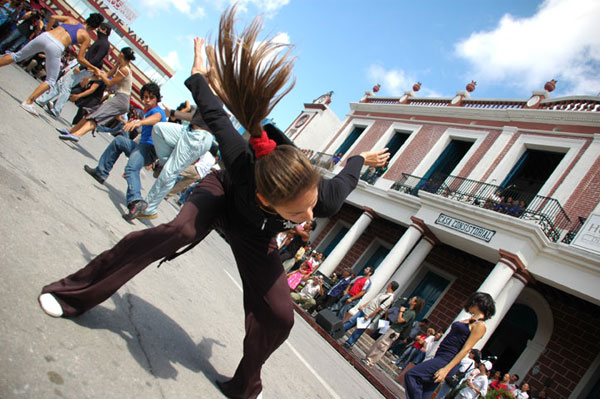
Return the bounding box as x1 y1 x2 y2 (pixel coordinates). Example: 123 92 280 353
219 228 294 399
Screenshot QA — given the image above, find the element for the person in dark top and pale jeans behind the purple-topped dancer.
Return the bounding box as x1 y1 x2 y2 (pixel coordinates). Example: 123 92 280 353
36 22 111 117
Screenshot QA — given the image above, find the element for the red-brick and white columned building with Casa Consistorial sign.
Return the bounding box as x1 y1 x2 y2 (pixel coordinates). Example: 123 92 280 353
287 81 600 399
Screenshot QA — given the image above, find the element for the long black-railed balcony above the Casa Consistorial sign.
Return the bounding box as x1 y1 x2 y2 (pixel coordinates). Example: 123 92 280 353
391 173 571 242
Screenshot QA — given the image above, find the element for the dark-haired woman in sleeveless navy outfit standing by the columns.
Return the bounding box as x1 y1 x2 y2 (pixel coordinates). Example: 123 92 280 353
404 292 496 399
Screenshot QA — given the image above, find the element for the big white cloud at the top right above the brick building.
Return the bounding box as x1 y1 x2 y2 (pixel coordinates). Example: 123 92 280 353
455 0 600 95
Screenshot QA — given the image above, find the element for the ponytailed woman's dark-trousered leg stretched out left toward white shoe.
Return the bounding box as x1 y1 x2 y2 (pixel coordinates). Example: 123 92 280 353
42 174 225 317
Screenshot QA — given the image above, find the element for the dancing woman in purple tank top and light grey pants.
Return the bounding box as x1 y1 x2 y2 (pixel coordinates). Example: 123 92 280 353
0 13 104 116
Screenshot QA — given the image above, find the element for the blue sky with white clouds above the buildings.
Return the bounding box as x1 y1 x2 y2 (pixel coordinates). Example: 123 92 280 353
123 0 600 129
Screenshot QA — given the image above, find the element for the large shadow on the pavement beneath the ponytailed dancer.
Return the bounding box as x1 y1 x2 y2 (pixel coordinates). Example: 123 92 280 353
73 294 227 384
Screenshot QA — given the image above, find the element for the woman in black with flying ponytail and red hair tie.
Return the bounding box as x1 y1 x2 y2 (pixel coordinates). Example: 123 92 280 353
39 7 389 399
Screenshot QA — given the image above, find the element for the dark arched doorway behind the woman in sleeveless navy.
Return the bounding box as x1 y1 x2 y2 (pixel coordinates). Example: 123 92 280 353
482 303 538 372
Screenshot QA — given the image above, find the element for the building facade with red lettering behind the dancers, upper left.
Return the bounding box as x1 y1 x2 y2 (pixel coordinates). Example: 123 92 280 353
40 0 175 107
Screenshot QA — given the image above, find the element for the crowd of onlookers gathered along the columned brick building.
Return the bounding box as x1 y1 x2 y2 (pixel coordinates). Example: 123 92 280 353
278 222 546 399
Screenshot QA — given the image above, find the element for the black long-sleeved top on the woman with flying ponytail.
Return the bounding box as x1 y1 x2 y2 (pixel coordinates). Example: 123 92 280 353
185 74 364 235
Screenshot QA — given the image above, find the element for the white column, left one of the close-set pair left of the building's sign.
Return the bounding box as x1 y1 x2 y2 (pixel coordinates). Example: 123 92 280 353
350 224 424 314
